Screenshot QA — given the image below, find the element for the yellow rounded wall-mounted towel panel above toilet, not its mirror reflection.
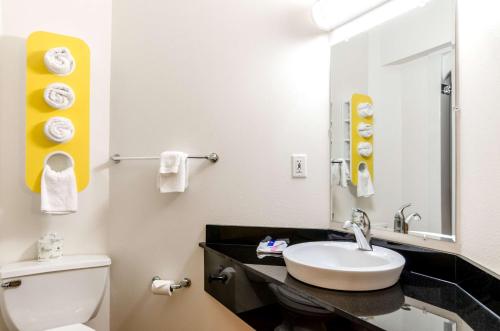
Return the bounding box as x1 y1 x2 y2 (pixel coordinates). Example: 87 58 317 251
25 32 90 192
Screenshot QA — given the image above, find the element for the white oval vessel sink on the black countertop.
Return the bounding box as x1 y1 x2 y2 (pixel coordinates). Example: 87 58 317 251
283 241 405 291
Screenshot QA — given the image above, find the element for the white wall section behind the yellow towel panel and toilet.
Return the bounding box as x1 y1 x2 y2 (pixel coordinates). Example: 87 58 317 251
0 0 111 330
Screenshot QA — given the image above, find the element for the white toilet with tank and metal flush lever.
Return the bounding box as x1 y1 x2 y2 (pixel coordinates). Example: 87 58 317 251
0 255 111 331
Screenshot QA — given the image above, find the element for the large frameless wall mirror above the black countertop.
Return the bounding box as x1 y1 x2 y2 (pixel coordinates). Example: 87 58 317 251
330 0 456 241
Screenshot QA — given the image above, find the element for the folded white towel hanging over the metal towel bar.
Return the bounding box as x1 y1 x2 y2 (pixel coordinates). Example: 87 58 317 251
157 151 189 193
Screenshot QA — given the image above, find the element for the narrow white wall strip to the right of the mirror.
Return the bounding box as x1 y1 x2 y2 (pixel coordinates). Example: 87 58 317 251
458 0 500 274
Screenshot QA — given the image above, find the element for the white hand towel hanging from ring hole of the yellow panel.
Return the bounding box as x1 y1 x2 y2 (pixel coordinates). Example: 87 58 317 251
41 164 78 215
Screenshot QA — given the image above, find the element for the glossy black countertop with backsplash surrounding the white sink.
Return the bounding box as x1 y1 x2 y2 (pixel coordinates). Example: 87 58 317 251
200 225 500 331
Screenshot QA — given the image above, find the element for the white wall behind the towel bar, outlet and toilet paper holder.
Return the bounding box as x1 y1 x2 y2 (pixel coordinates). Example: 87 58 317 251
109 0 329 331
